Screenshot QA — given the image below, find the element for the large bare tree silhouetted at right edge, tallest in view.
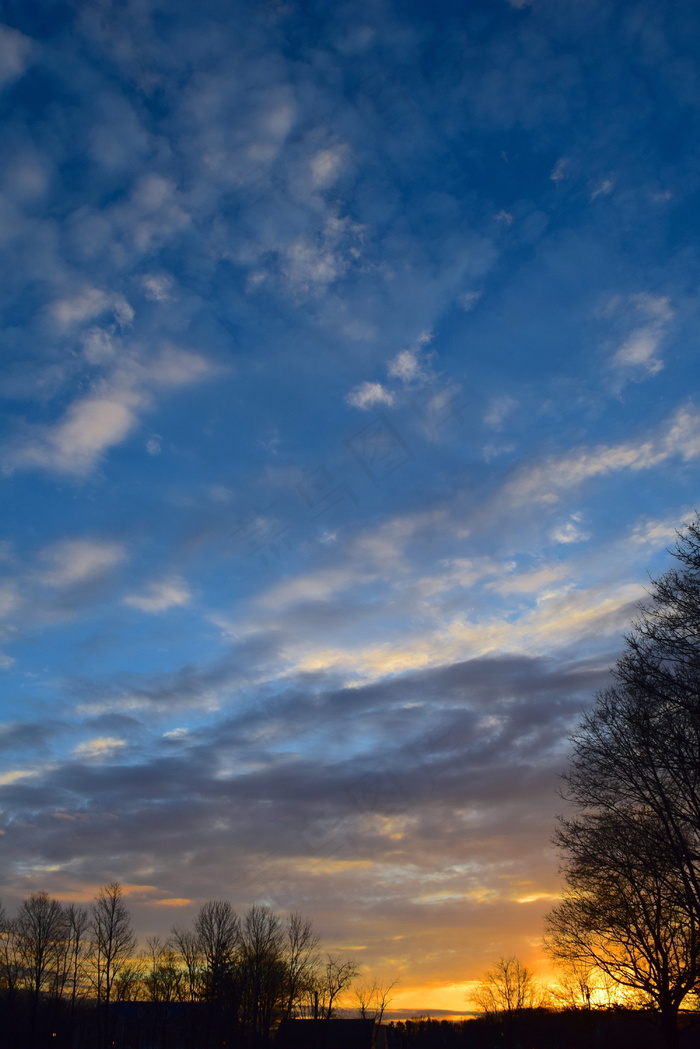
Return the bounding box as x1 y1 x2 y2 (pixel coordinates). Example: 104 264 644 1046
548 518 700 1047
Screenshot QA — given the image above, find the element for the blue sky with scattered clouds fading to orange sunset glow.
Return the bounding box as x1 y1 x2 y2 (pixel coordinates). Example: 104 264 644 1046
0 0 700 1014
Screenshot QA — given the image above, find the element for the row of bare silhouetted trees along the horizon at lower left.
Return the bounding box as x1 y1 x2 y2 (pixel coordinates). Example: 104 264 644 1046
0 883 358 1049
